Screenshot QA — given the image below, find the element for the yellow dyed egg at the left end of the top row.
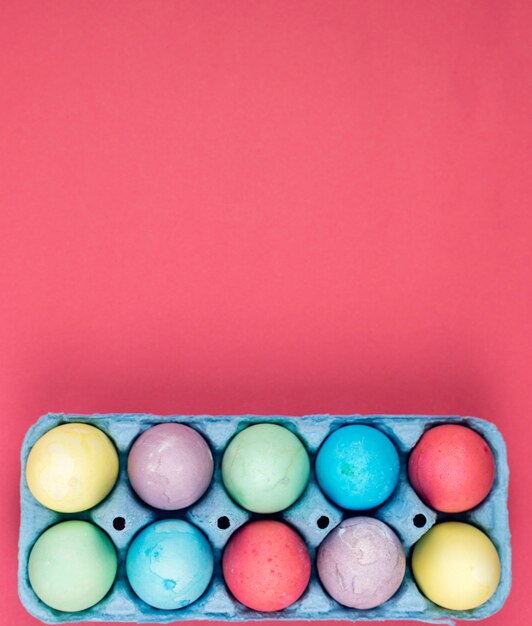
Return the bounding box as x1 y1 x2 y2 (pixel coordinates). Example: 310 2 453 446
26 424 118 513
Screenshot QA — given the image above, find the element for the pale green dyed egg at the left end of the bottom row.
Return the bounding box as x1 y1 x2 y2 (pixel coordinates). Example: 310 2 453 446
28 520 117 612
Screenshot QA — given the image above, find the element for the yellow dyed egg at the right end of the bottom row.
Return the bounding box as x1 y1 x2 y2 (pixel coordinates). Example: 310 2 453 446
412 522 500 611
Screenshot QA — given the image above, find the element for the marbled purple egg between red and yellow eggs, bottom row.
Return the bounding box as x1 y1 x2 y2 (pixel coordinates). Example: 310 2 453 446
317 517 405 609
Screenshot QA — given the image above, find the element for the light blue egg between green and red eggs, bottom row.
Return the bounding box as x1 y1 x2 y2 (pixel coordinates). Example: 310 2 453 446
126 519 214 609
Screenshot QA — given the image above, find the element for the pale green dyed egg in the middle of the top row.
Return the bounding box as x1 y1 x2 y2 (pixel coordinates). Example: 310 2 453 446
222 424 310 513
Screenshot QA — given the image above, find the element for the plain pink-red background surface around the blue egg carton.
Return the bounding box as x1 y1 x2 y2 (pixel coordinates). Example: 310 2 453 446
0 0 532 626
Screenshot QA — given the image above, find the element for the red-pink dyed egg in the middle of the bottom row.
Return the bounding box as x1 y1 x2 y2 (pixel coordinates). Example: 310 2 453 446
222 520 310 611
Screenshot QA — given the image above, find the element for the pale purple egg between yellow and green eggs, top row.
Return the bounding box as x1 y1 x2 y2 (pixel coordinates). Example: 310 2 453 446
127 424 213 511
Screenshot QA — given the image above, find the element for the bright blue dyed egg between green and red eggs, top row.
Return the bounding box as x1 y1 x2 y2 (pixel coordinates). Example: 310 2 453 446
316 424 399 511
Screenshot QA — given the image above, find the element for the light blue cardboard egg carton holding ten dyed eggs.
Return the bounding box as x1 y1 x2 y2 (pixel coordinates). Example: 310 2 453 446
18 413 511 624
